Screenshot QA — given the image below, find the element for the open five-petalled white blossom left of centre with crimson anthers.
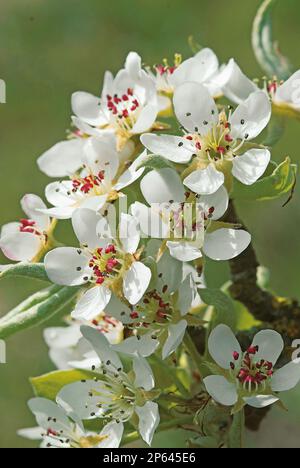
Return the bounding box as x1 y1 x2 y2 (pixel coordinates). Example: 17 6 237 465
45 208 151 320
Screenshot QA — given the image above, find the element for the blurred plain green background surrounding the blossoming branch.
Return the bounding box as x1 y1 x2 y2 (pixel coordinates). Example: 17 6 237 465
0 0 300 448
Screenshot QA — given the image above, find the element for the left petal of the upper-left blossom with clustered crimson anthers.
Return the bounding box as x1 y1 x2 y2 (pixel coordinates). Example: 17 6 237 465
72 91 103 126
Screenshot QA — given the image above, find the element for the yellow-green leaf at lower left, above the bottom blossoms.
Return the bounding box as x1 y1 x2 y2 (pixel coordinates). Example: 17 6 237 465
30 370 95 400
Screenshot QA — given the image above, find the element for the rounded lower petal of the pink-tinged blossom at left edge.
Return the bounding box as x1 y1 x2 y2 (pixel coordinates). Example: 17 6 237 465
0 232 42 262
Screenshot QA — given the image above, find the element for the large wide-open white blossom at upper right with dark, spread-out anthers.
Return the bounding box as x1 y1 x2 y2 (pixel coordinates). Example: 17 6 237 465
141 82 271 195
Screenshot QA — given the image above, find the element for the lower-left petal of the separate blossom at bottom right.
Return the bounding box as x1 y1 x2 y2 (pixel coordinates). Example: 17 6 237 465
204 375 238 406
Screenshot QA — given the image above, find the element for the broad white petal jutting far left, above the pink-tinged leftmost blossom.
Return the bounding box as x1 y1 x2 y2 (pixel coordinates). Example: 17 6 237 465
37 139 84 177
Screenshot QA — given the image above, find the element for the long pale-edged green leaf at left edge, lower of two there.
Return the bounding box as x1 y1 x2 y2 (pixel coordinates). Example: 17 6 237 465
0 287 79 339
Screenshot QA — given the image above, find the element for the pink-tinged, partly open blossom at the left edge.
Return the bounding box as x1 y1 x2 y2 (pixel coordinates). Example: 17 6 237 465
0 194 51 262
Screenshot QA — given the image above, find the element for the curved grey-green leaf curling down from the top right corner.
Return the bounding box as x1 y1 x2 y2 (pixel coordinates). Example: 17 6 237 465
252 0 293 80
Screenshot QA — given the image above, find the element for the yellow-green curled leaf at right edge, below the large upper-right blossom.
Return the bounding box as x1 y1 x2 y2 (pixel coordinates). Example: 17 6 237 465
232 158 297 201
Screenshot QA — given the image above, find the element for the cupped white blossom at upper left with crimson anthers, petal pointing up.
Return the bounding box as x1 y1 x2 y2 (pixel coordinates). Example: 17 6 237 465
72 52 159 151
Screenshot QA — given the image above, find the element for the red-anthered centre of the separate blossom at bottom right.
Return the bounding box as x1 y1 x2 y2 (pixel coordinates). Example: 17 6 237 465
230 346 274 393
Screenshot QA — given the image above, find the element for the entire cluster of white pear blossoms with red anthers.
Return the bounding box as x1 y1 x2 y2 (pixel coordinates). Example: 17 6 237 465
0 49 300 448
